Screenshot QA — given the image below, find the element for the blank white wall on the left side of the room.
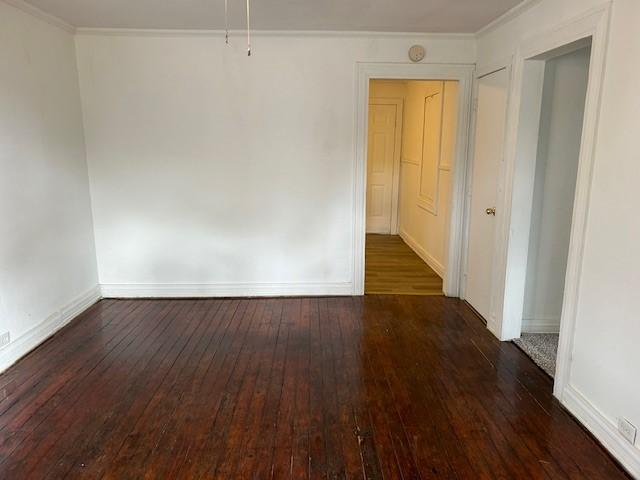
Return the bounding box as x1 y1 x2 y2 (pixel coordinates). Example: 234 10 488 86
0 2 98 370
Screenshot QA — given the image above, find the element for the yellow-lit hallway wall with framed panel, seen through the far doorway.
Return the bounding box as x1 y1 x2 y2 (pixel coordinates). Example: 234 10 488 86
400 80 458 276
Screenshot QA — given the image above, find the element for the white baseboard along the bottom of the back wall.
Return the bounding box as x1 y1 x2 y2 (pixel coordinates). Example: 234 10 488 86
101 282 353 298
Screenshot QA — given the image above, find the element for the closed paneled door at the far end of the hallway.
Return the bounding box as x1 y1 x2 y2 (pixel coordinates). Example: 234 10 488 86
367 99 402 234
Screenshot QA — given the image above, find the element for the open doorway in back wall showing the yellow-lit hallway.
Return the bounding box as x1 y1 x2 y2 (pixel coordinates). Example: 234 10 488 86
365 79 459 295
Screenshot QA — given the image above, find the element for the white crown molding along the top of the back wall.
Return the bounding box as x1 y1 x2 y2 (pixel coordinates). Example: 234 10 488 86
75 27 475 40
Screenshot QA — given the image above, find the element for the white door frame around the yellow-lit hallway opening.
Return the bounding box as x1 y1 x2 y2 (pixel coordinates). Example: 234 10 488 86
352 63 475 297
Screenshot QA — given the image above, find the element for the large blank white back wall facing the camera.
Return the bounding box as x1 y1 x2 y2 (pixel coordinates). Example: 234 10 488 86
77 32 475 295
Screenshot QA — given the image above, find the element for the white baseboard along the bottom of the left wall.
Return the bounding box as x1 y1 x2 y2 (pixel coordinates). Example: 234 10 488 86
0 285 101 372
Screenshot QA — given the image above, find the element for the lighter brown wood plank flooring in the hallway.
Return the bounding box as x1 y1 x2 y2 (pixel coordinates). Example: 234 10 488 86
364 234 442 295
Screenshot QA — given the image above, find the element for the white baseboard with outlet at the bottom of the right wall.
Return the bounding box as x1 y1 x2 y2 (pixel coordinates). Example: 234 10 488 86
561 385 640 478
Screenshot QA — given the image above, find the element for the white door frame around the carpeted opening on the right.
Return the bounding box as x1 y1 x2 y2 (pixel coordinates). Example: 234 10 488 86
488 4 610 402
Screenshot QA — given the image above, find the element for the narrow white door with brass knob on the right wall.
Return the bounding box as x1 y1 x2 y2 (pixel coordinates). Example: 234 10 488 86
465 70 509 320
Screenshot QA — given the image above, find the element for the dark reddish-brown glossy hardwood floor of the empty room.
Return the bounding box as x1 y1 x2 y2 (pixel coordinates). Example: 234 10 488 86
0 296 627 480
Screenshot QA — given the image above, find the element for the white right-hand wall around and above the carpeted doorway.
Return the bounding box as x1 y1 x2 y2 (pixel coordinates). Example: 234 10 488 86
478 0 640 476
